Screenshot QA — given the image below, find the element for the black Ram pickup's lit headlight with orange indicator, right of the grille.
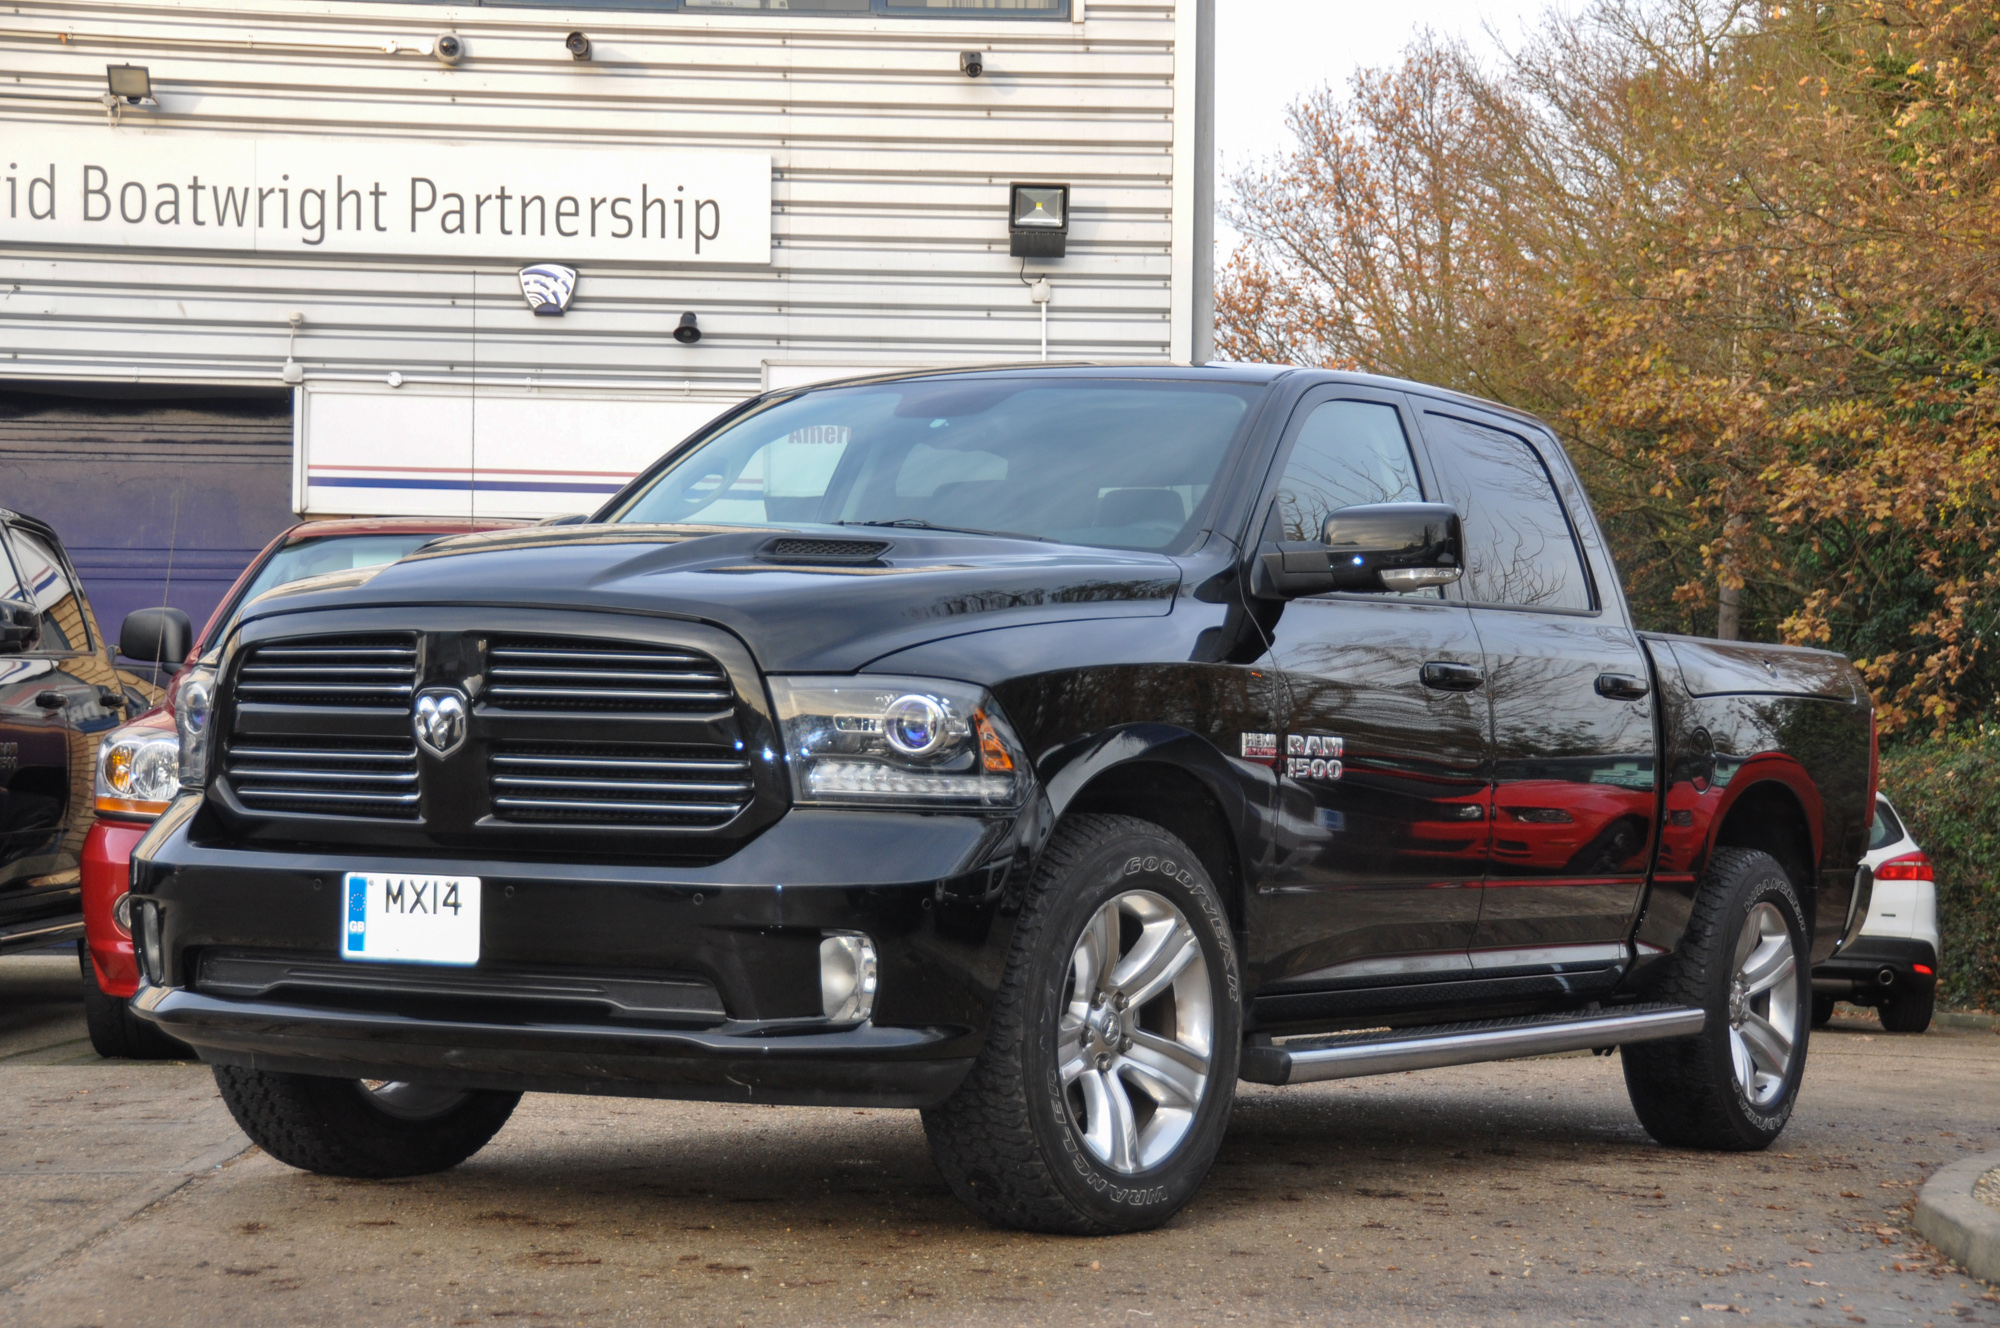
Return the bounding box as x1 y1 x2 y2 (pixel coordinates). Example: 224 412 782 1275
770 678 1030 808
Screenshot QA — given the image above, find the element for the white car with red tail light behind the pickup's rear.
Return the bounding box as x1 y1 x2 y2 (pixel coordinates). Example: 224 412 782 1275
1812 794 1938 1032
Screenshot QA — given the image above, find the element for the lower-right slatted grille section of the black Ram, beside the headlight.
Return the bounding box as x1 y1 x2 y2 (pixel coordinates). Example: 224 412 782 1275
492 742 756 830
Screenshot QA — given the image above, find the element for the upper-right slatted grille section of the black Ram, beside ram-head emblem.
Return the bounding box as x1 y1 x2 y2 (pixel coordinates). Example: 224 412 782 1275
480 638 736 714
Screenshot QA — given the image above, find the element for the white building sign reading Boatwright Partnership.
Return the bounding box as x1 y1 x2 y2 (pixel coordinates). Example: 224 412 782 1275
0 124 772 264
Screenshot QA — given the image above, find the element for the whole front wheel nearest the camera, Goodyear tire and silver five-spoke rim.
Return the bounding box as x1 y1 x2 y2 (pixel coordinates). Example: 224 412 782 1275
924 816 1242 1236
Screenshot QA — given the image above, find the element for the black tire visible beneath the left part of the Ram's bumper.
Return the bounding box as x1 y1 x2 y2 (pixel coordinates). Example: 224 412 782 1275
216 1066 520 1180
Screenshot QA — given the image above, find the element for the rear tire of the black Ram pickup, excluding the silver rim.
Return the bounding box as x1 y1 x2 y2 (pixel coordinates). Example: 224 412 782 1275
1620 848 1812 1152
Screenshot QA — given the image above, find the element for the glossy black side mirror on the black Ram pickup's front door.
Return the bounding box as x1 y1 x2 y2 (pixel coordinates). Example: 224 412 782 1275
1258 502 1464 598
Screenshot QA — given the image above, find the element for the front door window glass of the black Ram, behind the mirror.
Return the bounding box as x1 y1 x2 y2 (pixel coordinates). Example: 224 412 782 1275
1278 402 1424 540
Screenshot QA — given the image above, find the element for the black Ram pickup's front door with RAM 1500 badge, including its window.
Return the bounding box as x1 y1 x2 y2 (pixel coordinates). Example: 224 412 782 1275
1250 388 1488 1022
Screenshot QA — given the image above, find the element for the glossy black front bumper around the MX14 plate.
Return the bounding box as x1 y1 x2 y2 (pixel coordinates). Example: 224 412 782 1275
132 810 1038 1106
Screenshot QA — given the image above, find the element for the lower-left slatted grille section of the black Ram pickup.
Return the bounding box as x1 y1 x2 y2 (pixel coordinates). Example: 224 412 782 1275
226 734 416 820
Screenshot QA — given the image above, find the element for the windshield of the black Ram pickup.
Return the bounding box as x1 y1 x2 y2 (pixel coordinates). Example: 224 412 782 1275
598 378 1264 550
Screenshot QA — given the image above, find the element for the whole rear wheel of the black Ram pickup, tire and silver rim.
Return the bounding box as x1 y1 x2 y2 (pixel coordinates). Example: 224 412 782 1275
1620 848 1812 1152
